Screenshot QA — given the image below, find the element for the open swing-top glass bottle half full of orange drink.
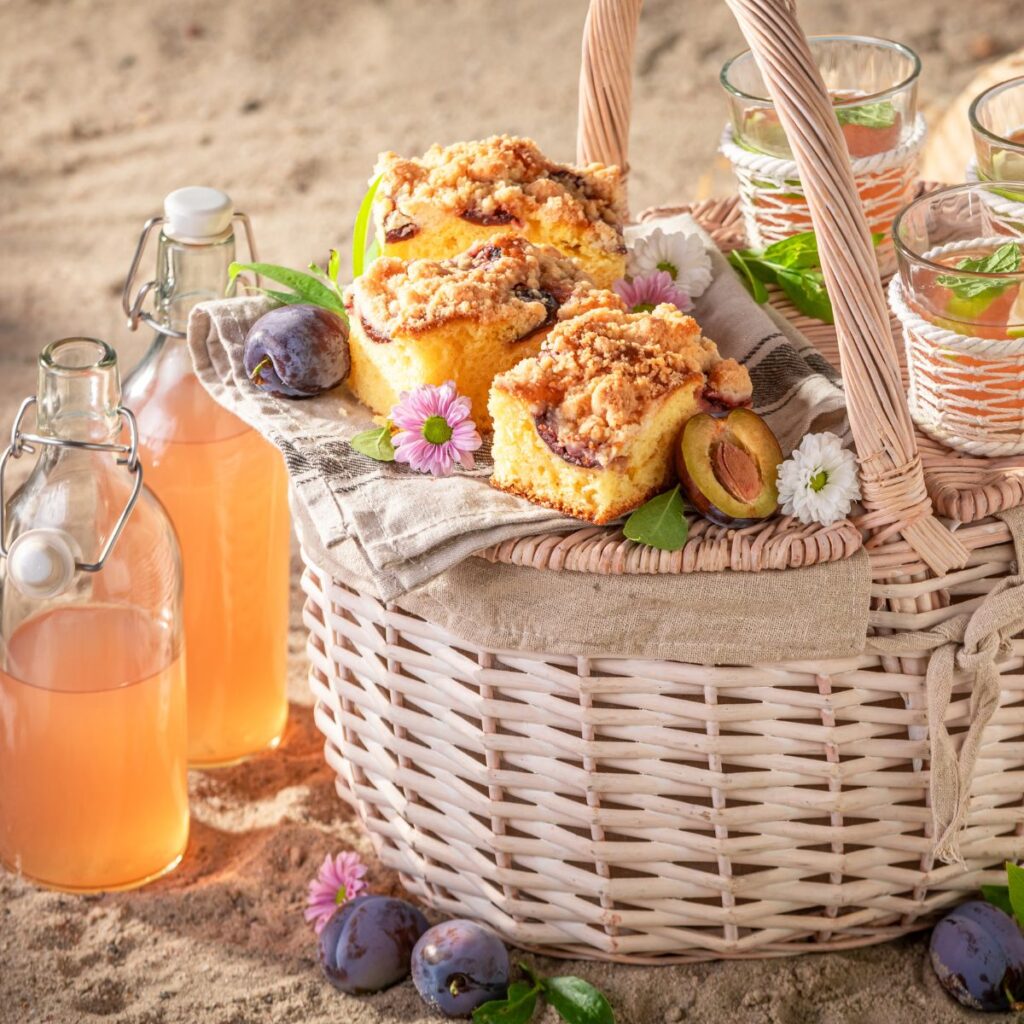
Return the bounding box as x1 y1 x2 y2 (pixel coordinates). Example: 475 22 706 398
0 338 188 891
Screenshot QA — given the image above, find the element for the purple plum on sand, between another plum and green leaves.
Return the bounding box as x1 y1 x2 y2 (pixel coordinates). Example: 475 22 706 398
405 920 510 1017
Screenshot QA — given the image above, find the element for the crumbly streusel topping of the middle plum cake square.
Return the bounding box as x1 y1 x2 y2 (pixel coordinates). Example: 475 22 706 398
349 234 623 339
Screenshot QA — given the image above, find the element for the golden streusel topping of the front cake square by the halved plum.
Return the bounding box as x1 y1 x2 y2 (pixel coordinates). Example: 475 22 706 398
495 304 751 465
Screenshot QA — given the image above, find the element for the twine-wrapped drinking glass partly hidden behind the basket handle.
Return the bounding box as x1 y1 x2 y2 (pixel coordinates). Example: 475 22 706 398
721 36 926 271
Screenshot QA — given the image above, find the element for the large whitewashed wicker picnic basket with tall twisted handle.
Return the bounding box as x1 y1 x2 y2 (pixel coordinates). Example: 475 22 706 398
303 0 1024 963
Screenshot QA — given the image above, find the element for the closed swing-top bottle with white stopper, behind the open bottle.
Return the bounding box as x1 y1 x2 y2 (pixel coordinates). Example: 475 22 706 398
125 188 291 766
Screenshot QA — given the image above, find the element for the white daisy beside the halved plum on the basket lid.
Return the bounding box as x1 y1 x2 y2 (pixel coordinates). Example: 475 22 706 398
778 433 860 526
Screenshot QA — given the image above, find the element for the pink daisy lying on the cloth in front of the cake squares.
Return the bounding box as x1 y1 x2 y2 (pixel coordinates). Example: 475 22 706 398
391 381 483 476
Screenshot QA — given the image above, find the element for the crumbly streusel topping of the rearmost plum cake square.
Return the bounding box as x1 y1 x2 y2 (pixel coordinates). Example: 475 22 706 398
374 135 626 252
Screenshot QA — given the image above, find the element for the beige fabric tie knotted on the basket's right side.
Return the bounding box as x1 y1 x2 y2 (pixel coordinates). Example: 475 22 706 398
868 509 1024 867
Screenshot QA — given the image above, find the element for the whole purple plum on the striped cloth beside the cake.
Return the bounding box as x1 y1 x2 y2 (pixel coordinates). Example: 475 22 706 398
243 305 351 398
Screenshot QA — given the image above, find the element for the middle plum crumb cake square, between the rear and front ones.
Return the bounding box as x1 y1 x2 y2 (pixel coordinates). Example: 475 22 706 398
346 234 623 431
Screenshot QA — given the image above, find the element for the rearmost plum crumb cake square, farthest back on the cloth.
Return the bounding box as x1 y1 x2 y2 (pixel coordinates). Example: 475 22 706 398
374 135 626 288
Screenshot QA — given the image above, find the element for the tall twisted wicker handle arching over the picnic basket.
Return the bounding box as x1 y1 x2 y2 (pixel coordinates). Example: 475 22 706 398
579 0 969 575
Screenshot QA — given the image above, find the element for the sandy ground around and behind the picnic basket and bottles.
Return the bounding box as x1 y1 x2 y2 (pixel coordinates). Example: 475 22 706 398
6 0 1024 1024
